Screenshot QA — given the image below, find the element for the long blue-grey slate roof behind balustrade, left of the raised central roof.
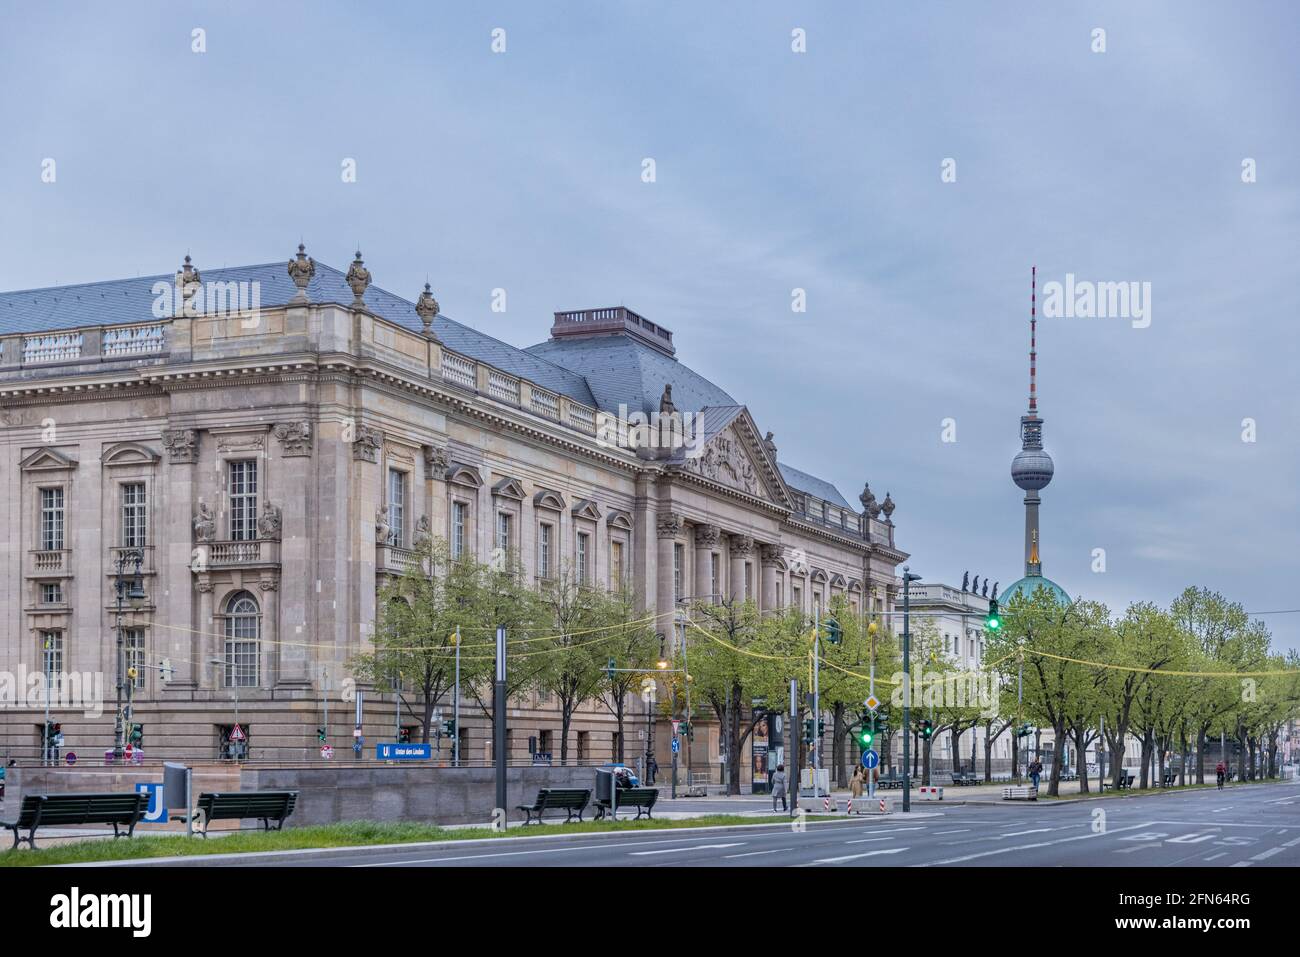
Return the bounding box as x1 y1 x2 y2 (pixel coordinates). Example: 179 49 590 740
0 260 595 406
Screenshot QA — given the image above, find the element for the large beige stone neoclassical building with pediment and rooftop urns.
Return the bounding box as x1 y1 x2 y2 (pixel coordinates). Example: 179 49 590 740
0 247 905 765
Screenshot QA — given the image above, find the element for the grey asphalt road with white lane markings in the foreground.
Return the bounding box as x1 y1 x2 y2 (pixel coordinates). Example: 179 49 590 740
124 783 1300 867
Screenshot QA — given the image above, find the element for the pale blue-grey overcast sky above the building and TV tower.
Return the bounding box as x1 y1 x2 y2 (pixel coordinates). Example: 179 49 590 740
0 0 1300 648
